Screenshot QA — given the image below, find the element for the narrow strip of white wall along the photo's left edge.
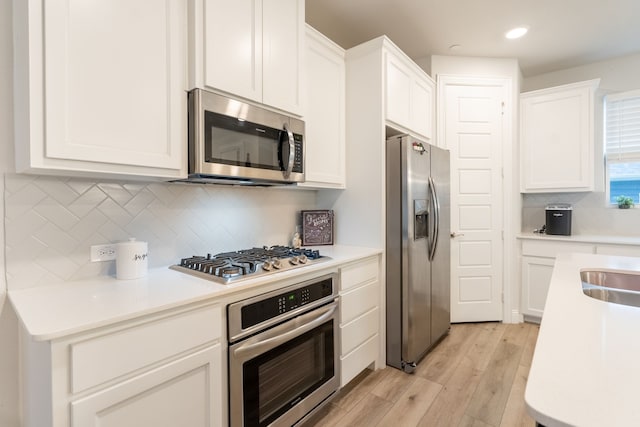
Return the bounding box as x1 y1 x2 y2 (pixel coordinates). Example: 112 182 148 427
0 0 19 427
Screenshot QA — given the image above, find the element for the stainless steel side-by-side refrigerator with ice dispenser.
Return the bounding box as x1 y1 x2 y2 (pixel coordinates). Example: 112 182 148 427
386 135 451 372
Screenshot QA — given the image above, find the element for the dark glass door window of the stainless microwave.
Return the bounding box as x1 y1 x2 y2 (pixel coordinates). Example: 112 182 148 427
204 111 289 171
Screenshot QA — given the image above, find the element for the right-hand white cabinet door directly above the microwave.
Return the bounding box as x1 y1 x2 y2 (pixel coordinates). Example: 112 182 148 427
262 0 305 114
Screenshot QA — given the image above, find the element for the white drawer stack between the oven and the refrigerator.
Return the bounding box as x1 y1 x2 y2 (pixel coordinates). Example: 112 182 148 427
340 256 380 387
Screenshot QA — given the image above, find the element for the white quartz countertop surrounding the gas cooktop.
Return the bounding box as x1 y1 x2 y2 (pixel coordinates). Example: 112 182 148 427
8 246 382 341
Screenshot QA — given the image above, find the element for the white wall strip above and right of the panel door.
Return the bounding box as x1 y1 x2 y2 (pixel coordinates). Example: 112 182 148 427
430 55 522 322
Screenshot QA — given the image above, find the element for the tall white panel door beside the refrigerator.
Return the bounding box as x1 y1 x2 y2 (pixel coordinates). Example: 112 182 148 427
441 79 506 322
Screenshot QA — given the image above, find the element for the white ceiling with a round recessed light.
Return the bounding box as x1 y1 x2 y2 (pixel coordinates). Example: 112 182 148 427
306 0 640 77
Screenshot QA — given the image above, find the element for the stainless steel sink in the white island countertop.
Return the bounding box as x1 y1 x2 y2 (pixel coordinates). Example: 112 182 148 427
580 270 640 307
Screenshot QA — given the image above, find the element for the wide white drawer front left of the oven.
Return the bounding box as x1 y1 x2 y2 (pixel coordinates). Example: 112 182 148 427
71 306 221 393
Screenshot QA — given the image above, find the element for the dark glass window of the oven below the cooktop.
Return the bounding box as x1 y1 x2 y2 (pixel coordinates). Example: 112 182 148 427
243 320 335 426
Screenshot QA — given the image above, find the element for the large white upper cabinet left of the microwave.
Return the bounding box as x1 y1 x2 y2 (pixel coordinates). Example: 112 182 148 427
14 0 187 179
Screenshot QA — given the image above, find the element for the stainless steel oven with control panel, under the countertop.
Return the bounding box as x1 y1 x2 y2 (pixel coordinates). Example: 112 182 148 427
227 274 340 426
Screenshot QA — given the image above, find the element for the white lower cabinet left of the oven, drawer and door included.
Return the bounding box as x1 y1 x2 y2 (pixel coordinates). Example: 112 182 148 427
21 304 224 427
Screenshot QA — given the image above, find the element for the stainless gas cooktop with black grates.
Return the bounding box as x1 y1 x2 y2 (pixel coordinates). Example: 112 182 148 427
169 246 331 284
